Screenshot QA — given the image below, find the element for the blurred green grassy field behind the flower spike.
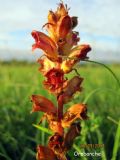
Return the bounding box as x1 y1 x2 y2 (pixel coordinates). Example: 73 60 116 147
0 62 120 160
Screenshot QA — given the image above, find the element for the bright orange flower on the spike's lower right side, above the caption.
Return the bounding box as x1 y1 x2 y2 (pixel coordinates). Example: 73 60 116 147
62 104 88 128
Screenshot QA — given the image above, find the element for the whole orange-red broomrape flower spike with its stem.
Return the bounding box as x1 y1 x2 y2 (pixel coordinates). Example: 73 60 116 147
31 3 91 160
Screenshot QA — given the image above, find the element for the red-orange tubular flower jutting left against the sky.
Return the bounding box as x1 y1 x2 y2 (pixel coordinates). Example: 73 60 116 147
31 31 57 60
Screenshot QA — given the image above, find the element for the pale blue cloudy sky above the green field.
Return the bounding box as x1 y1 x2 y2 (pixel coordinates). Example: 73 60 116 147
0 0 120 62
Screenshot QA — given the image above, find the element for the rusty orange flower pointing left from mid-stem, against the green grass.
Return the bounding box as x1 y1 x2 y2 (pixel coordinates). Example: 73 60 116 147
31 95 57 114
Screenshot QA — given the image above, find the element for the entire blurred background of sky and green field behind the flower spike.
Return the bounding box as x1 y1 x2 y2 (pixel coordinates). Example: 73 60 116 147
0 0 120 160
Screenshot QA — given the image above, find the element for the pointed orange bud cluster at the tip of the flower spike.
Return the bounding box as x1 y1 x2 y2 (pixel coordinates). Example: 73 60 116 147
46 3 72 43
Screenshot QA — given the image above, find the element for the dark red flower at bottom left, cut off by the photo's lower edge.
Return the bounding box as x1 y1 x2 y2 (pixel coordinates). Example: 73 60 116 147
36 145 57 160
